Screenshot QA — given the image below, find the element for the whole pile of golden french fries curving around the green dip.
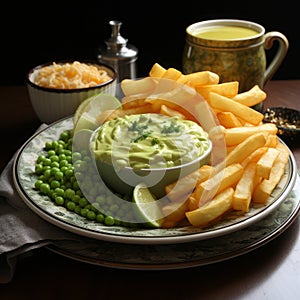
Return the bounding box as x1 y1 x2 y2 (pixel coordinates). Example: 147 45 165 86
98 63 289 228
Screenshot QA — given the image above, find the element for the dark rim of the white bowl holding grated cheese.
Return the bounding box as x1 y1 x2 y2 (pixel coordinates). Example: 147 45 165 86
26 59 118 94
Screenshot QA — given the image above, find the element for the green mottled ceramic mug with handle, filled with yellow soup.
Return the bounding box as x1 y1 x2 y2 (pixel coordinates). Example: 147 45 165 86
182 19 289 104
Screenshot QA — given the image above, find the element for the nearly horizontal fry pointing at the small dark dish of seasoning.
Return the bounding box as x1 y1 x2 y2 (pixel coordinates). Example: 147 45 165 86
224 123 278 146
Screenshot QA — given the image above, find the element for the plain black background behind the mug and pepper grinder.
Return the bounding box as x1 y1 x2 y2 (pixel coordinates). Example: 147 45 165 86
0 0 300 85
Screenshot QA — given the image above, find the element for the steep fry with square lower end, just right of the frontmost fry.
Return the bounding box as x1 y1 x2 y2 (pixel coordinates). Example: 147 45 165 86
232 162 256 212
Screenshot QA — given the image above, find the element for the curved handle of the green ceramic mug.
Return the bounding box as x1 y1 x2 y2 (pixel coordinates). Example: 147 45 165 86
263 31 289 86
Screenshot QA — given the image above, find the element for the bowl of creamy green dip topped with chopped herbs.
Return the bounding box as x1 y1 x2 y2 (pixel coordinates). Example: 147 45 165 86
90 113 212 198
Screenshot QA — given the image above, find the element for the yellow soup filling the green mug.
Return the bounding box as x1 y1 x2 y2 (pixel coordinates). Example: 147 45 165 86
195 25 258 40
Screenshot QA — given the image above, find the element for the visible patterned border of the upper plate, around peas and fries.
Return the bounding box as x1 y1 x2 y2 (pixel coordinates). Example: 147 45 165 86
14 118 297 245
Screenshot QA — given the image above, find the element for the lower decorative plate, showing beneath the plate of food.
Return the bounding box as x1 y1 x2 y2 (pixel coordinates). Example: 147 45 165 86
47 176 300 270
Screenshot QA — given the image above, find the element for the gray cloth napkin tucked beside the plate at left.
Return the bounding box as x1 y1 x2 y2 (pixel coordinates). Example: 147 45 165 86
0 128 82 283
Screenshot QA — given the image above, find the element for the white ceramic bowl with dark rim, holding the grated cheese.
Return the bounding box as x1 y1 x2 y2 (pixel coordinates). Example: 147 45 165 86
26 61 117 124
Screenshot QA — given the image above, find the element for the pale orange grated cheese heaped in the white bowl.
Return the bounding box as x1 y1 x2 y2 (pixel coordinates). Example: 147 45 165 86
34 61 112 89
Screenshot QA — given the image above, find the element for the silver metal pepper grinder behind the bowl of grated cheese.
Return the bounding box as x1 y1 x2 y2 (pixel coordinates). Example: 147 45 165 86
98 21 138 82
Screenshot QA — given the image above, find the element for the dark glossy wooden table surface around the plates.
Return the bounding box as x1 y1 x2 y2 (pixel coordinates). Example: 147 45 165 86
0 80 300 300
